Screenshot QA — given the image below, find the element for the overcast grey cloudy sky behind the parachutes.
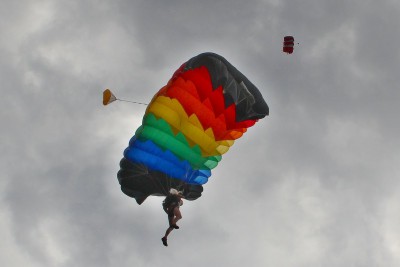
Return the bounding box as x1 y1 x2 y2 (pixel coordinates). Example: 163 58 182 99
0 0 400 267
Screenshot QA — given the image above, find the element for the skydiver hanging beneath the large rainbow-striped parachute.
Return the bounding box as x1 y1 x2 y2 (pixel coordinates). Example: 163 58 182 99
161 188 185 246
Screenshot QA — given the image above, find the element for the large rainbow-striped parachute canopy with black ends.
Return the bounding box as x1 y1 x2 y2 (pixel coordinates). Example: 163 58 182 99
117 53 269 205
